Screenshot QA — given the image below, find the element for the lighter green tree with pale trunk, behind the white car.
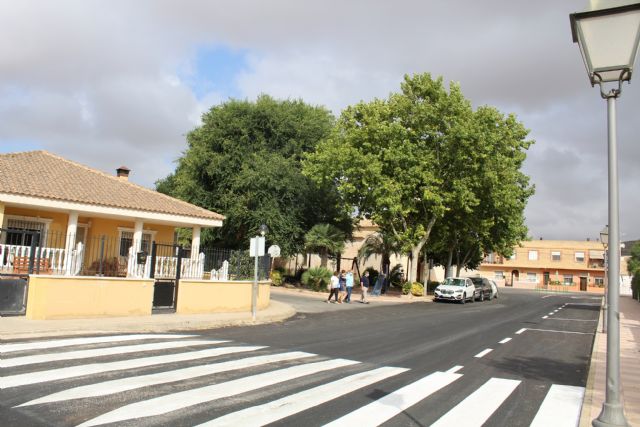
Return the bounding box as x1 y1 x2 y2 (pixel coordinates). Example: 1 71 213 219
304 73 533 281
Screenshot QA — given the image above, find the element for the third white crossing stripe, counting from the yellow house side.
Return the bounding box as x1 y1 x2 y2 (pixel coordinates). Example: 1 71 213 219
2 346 265 388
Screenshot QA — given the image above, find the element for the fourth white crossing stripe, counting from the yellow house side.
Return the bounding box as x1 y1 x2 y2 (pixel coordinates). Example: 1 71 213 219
18 351 315 406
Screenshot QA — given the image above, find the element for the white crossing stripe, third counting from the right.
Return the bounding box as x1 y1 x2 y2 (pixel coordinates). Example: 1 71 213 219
326 372 462 427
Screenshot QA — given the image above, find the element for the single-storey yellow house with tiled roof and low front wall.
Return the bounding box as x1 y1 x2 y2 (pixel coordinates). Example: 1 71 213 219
0 151 268 318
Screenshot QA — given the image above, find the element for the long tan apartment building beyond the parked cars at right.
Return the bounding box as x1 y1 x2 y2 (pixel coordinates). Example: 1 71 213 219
479 240 605 293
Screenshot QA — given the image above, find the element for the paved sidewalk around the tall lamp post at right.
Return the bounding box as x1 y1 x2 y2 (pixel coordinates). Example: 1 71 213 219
580 296 640 427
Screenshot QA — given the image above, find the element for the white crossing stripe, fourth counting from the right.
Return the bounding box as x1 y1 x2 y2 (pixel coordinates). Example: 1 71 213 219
198 367 408 427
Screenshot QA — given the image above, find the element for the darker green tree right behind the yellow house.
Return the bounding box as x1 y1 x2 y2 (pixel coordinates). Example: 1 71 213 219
157 95 351 255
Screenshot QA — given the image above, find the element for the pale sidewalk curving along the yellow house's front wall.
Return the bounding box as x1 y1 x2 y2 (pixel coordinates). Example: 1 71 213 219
0 300 296 340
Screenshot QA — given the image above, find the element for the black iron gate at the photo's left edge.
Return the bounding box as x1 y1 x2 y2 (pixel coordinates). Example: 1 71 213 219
0 228 41 316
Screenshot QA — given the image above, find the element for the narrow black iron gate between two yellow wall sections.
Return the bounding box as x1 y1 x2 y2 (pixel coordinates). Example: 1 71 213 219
150 242 184 313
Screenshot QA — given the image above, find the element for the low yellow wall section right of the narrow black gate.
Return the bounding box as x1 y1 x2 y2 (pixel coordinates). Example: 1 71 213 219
176 280 271 314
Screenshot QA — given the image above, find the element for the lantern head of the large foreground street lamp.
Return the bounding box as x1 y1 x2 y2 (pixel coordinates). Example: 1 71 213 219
569 3 640 90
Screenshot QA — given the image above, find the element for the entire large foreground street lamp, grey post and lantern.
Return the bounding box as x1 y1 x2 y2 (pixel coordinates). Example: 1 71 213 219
570 3 640 427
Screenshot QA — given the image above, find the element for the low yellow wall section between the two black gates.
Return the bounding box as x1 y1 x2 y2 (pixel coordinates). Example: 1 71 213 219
26 276 153 320
